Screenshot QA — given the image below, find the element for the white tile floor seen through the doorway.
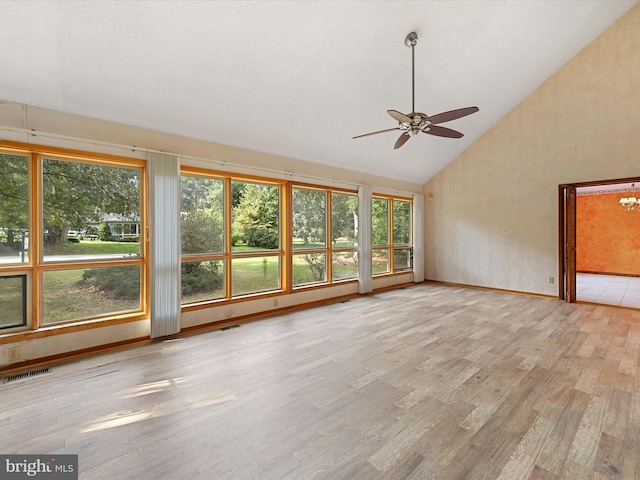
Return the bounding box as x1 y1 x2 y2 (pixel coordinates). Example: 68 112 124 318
576 273 640 308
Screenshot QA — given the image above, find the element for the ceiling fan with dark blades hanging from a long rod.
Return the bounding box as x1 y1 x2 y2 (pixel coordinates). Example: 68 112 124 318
353 32 479 150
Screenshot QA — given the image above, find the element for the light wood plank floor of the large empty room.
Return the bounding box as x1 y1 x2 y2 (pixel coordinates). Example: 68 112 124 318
0 283 640 480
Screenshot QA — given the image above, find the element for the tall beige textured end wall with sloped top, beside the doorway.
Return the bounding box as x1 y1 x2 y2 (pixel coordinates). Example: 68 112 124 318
424 5 640 295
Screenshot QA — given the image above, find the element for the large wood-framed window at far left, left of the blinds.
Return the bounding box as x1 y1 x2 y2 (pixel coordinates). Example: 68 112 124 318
0 146 146 329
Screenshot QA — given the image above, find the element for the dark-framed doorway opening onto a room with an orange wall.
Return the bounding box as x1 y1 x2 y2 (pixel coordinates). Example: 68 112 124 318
558 178 640 308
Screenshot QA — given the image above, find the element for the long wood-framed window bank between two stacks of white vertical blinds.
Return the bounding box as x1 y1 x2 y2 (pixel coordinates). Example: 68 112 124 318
180 172 358 305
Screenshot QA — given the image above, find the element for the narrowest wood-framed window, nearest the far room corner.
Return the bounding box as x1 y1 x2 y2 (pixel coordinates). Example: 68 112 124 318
371 197 413 275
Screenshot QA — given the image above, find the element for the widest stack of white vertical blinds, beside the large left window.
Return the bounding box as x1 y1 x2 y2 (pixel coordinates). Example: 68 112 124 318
148 152 180 338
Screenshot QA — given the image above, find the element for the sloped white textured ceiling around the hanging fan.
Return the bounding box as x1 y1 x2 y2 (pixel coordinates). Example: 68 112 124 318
0 0 636 184
